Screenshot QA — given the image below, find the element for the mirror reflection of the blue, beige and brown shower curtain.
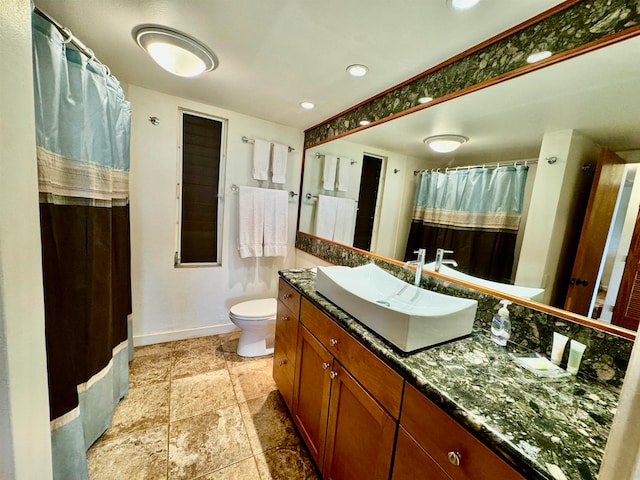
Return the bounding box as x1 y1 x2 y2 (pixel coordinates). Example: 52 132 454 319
405 165 529 283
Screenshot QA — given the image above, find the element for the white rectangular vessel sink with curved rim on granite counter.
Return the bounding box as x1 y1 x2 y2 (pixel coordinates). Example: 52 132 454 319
316 263 478 352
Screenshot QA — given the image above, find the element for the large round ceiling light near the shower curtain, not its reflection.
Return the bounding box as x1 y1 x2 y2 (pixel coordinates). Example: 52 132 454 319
133 26 218 77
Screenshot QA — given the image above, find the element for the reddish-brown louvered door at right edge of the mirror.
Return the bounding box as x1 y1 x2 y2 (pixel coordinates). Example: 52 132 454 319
611 212 640 330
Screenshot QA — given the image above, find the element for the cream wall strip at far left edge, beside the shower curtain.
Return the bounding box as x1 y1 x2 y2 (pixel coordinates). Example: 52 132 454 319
0 0 52 480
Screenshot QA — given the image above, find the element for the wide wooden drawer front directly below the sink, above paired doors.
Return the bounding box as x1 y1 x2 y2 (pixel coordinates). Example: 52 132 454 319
300 298 403 419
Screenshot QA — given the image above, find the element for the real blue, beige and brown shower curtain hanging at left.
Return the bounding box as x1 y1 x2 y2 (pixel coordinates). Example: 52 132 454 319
31 12 131 480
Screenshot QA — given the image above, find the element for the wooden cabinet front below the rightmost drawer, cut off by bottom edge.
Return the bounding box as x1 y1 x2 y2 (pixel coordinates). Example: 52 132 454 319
391 427 451 480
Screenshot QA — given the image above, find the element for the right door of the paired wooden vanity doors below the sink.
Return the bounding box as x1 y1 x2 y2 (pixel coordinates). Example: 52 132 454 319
322 361 396 480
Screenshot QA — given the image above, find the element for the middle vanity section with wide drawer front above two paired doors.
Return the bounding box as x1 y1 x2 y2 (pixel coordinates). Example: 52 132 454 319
292 298 403 480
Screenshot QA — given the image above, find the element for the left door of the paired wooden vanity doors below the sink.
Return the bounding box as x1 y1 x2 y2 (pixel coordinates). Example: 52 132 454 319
292 325 333 468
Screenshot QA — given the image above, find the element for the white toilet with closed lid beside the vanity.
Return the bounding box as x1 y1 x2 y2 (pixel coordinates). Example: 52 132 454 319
229 298 278 357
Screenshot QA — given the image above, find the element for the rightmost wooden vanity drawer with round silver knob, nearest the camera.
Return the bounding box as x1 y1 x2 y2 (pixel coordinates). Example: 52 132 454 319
400 385 523 480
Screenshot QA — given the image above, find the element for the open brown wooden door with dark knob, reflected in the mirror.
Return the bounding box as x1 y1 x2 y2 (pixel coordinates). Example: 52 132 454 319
564 148 625 315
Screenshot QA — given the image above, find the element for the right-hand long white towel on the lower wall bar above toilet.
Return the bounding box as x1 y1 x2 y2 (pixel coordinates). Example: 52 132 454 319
264 190 289 257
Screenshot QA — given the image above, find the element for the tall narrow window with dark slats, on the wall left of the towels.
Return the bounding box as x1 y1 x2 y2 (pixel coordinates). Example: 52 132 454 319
175 112 226 265
